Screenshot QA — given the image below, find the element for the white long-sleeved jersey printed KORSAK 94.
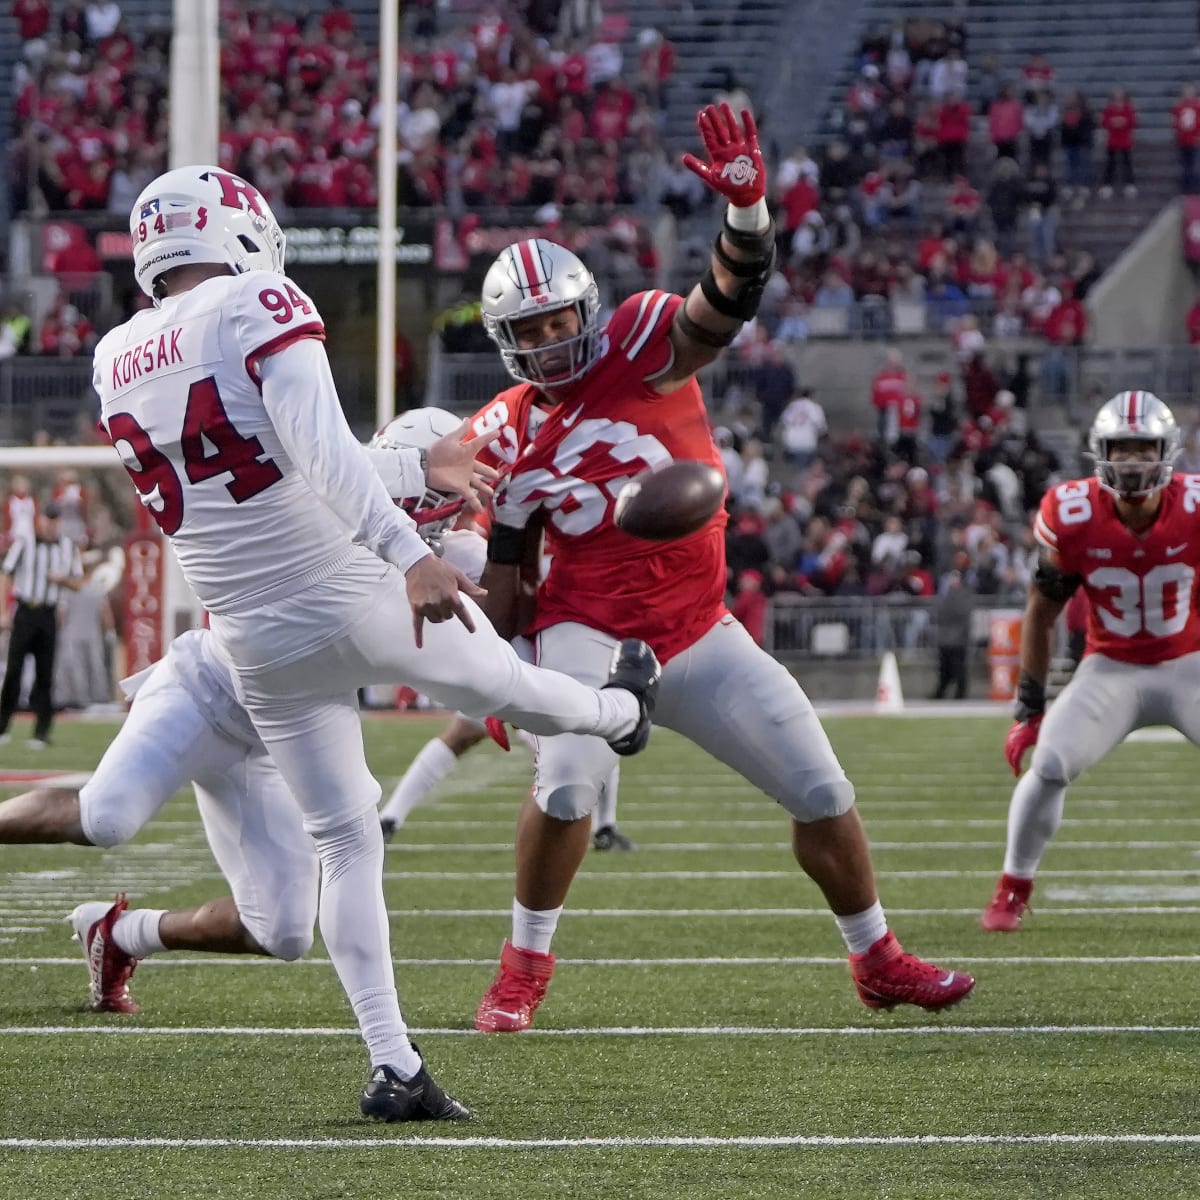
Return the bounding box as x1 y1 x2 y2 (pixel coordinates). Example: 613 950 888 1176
94 271 429 613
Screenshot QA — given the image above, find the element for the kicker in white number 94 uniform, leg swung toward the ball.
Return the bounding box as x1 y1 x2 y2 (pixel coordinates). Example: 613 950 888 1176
94 167 656 1120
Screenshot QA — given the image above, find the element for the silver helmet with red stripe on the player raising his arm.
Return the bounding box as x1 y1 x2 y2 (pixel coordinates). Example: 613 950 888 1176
482 238 600 388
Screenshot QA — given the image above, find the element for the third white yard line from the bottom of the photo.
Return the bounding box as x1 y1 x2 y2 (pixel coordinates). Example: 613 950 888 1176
7 950 1200 970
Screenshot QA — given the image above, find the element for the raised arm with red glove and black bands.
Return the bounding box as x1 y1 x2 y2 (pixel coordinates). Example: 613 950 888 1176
655 103 775 390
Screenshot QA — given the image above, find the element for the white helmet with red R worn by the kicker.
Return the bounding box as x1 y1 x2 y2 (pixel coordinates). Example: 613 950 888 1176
130 167 286 305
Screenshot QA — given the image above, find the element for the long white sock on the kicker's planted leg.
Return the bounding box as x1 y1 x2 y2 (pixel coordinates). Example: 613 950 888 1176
314 809 421 1079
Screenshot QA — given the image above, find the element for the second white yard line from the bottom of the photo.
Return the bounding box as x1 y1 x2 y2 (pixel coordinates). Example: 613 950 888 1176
0 1025 1200 1038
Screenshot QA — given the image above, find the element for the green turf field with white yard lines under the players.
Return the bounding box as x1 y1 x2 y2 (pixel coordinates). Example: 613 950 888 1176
0 718 1200 1200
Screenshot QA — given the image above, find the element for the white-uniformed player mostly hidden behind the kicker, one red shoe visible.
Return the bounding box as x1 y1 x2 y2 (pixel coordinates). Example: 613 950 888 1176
0 409 487 1013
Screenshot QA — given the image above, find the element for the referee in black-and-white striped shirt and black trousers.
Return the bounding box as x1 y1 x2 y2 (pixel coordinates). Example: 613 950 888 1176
0 504 83 750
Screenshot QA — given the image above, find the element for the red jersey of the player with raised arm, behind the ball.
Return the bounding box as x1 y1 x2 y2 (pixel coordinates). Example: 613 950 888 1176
494 292 727 662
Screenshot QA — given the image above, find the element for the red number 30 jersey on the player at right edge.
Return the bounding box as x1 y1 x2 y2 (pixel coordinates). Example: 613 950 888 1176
1033 475 1200 665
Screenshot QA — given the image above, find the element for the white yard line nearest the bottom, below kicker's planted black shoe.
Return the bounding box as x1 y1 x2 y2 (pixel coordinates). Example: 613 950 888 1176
0 1133 1200 1152
